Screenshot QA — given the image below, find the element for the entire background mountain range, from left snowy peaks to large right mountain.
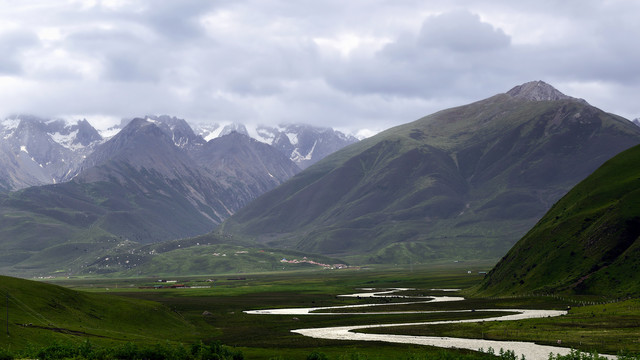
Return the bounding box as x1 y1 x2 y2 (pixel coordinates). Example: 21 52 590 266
0 81 640 274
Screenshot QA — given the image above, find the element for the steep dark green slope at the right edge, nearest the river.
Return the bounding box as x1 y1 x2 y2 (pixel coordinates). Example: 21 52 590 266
479 146 640 297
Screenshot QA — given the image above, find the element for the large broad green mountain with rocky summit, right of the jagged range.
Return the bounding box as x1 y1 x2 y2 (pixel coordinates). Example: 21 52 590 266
219 84 640 263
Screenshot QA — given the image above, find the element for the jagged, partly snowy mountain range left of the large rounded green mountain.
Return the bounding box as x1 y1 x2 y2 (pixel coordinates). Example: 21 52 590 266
0 116 360 273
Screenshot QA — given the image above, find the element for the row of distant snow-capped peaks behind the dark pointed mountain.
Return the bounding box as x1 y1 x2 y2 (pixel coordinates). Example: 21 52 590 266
0 115 358 191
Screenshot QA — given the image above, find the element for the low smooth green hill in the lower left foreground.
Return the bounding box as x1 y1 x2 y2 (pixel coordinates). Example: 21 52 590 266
0 276 198 349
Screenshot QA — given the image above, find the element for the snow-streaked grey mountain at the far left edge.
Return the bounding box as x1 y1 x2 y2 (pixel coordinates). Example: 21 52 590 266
0 115 103 191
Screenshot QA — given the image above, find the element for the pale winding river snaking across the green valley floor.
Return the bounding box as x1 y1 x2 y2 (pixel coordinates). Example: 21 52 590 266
245 288 616 360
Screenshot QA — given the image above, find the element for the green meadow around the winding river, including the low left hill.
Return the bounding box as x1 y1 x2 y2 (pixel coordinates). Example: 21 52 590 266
0 262 640 359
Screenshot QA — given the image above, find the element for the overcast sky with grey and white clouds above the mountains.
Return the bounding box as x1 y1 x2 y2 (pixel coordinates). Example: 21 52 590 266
0 0 640 134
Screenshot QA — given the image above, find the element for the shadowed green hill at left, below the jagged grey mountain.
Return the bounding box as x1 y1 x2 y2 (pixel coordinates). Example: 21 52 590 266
0 178 220 276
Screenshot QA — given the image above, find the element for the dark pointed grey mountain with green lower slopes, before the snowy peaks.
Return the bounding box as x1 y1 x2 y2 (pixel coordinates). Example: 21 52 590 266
0 118 300 250
